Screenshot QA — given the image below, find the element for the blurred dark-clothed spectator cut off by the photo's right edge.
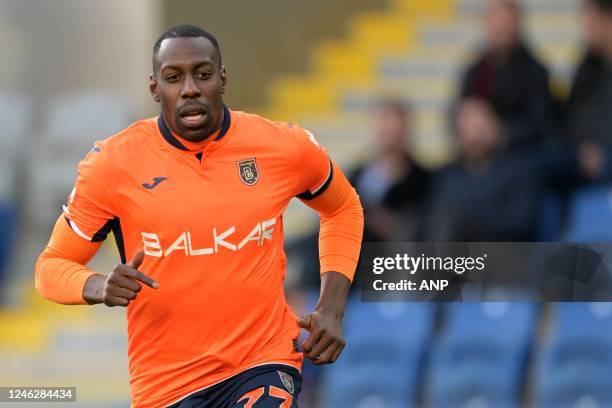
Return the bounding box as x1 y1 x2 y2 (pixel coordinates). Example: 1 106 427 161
566 0 612 173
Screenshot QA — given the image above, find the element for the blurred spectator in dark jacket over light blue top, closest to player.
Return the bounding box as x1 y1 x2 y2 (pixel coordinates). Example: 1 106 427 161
350 99 430 242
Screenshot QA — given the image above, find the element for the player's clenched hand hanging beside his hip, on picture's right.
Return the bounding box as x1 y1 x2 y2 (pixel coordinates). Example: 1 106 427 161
297 310 346 365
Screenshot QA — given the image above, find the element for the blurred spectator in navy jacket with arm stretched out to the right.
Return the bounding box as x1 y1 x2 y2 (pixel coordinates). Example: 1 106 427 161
428 98 588 241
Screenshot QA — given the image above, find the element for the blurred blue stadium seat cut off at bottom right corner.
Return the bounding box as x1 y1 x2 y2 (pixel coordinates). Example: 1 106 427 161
536 302 612 408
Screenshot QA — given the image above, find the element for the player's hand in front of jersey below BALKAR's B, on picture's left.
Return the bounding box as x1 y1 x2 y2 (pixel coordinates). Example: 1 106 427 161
102 250 159 307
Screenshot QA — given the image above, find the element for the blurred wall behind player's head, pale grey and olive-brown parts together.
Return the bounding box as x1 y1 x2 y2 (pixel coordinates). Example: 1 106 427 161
0 0 386 117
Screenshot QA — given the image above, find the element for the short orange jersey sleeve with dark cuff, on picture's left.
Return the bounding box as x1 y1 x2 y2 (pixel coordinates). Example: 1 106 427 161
64 142 117 242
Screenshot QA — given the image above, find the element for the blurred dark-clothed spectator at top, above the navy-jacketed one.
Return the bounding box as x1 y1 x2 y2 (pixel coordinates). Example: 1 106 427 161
460 0 555 147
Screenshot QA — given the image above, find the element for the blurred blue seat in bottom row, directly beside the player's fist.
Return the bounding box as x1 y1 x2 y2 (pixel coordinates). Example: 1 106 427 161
321 298 435 408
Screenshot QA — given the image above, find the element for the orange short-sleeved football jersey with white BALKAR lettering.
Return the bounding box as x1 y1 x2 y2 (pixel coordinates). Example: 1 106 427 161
64 108 333 407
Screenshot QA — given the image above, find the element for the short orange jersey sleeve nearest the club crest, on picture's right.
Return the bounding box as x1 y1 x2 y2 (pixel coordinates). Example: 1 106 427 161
289 125 333 200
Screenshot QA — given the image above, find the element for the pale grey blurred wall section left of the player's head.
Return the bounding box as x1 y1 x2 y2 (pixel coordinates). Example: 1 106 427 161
0 0 160 119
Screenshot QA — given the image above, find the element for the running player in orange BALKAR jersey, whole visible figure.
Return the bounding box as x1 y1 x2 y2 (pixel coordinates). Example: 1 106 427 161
35 26 363 408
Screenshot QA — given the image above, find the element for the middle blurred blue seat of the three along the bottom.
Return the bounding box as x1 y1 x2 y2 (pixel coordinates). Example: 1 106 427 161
426 302 537 407
